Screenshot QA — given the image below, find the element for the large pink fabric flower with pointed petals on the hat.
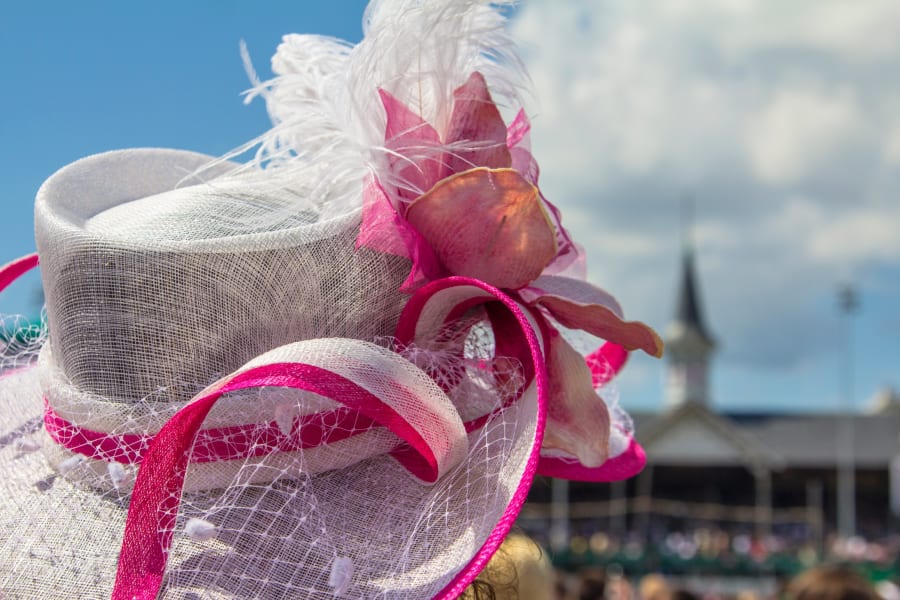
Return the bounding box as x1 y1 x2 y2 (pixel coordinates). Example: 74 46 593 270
357 72 663 468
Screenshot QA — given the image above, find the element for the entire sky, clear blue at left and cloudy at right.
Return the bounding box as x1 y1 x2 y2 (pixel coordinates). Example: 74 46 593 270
0 0 900 410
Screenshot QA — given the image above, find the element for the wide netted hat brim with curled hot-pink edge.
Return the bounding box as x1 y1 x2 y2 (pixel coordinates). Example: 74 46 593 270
0 274 544 598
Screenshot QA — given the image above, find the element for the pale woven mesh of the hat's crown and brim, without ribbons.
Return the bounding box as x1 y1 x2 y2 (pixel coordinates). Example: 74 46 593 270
0 150 537 600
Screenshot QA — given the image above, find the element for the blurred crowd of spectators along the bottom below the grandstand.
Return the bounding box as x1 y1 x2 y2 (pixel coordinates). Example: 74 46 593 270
464 530 900 600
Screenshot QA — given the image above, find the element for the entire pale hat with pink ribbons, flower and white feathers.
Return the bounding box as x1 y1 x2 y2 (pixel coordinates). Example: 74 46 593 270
0 0 661 600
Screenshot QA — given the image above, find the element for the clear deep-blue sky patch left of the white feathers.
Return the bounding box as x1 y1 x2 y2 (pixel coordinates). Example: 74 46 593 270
0 0 365 314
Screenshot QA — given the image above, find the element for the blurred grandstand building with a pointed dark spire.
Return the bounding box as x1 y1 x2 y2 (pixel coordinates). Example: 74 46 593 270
522 249 900 564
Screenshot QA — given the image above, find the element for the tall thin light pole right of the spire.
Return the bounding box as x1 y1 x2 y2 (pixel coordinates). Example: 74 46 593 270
837 284 859 539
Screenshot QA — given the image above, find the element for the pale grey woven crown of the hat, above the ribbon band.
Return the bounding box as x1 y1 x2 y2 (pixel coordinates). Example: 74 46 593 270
35 149 405 403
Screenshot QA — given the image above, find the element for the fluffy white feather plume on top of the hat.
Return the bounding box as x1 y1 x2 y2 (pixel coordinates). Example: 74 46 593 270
229 0 527 218
